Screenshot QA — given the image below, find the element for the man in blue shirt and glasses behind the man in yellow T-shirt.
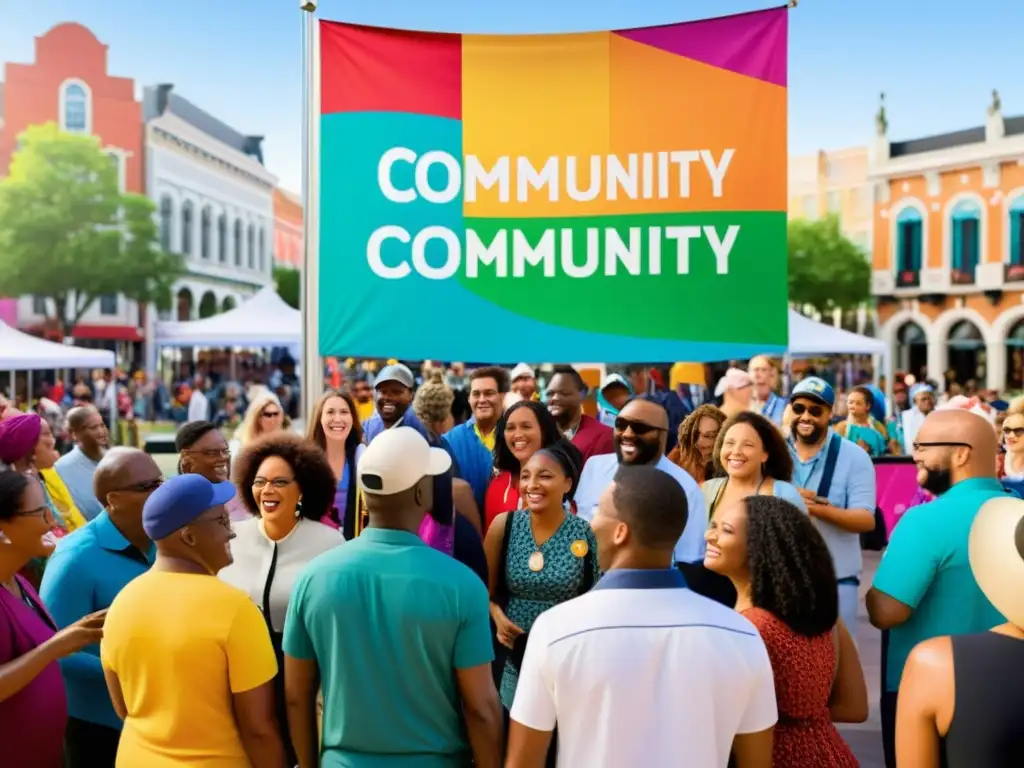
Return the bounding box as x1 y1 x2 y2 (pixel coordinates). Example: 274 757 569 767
39 447 163 768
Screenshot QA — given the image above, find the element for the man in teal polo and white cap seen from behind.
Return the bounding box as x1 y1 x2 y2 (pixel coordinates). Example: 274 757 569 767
284 427 502 768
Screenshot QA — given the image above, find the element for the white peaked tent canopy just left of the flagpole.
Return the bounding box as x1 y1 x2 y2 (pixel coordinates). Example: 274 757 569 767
156 286 302 347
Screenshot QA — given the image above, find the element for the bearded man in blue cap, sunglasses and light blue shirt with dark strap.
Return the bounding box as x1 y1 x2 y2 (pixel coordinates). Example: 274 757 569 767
790 376 877 628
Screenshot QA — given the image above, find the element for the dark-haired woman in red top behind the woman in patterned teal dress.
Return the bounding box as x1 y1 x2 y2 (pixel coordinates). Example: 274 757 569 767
483 400 562 534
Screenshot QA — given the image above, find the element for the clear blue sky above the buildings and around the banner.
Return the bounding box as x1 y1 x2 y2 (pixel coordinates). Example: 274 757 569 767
0 0 1024 190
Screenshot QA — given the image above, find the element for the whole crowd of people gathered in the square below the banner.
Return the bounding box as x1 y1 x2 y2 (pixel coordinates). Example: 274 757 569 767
0 357 1024 768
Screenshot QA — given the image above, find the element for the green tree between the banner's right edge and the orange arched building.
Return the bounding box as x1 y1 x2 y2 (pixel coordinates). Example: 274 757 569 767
790 216 871 315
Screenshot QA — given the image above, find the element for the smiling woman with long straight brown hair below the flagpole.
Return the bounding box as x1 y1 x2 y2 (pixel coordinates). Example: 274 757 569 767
306 389 367 539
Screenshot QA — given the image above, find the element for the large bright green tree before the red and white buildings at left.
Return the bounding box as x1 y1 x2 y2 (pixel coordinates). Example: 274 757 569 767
0 123 182 333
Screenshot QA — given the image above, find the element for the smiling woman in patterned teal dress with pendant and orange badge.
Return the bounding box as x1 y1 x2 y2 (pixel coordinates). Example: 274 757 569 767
484 439 598 713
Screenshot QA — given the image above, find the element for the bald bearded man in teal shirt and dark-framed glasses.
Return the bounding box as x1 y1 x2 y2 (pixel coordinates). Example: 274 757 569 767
866 409 1007 766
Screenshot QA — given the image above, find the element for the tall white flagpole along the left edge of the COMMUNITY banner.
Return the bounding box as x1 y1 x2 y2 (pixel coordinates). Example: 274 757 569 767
299 0 324 418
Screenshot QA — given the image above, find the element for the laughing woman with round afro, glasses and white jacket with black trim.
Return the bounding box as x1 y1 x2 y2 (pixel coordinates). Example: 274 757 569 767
218 432 345 765
